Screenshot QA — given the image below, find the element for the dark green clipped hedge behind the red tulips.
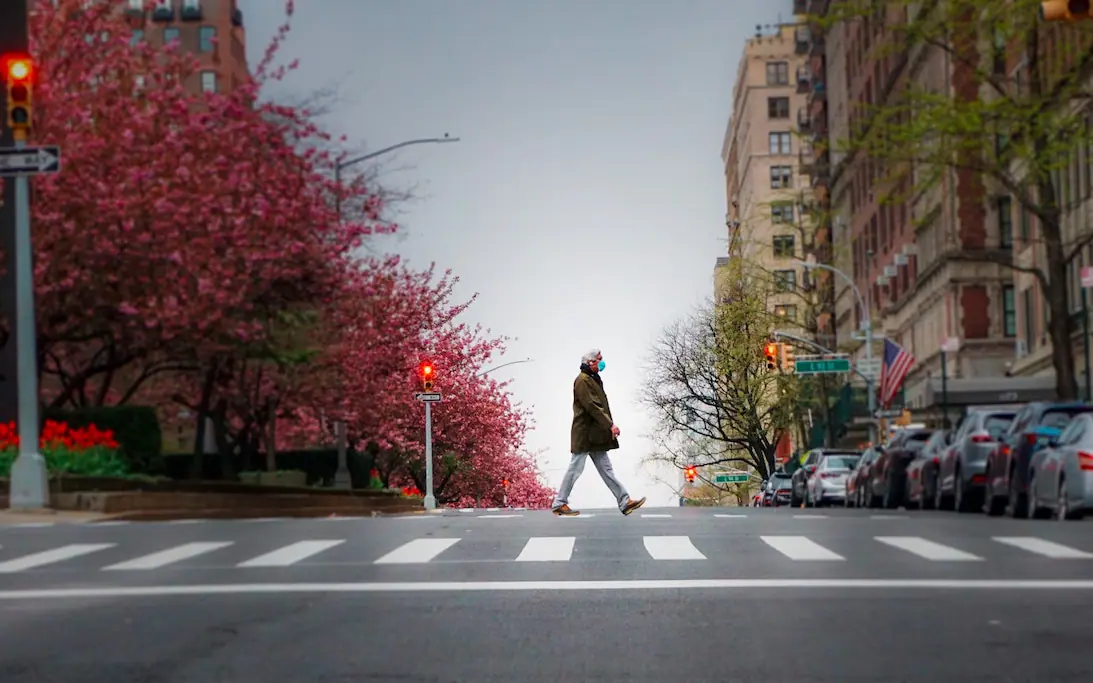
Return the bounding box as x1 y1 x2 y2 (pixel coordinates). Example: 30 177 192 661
42 405 163 473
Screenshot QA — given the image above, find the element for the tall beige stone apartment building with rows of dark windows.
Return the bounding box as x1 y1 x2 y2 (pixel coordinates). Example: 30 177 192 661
715 25 811 327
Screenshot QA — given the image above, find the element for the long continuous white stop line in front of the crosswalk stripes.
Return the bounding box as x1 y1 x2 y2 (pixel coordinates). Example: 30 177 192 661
0 579 1093 601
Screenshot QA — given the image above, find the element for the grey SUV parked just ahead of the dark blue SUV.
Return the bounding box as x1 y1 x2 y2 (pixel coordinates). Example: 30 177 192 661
933 407 1016 513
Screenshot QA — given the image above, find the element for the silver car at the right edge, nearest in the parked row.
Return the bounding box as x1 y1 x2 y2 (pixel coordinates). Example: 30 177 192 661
1029 413 1093 520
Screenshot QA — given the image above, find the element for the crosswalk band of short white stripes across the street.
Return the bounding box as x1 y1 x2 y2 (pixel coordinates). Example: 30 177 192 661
0 534 1093 574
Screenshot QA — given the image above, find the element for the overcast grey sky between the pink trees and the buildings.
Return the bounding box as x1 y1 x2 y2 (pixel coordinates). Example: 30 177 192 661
240 0 791 508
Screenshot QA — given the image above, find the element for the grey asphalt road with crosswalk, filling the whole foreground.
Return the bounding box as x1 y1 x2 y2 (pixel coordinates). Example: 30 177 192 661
0 508 1093 683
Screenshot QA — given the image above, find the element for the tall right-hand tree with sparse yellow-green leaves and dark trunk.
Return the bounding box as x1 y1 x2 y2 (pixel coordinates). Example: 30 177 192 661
810 0 1093 399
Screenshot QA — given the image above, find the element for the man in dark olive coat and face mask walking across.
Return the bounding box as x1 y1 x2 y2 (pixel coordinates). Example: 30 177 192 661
551 349 645 517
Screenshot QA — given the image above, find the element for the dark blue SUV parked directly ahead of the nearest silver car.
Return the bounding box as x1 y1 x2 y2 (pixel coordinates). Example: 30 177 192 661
983 401 1093 519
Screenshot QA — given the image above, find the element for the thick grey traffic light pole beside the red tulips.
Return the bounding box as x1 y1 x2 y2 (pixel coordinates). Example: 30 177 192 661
10 141 49 509
